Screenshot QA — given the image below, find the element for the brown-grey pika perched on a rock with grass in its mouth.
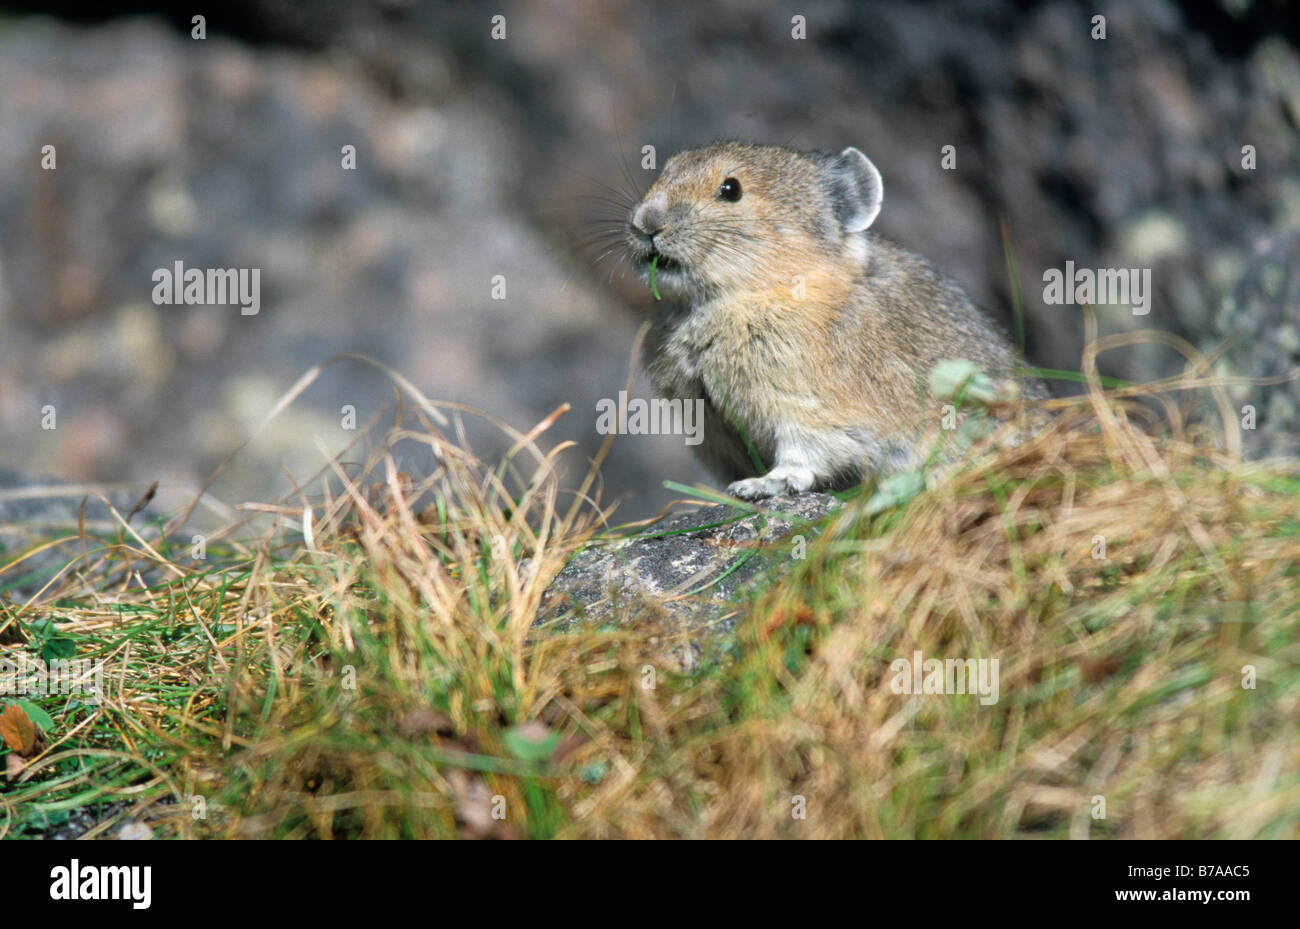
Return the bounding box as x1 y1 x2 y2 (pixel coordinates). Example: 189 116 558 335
627 142 1047 500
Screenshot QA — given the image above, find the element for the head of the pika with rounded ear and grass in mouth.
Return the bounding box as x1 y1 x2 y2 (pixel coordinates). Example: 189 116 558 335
627 142 884 298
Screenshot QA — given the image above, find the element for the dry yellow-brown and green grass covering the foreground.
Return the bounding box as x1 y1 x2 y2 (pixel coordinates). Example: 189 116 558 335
0 350 1300 838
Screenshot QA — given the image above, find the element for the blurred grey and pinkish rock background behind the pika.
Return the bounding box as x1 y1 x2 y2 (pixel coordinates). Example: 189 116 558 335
0 0 1300 530
